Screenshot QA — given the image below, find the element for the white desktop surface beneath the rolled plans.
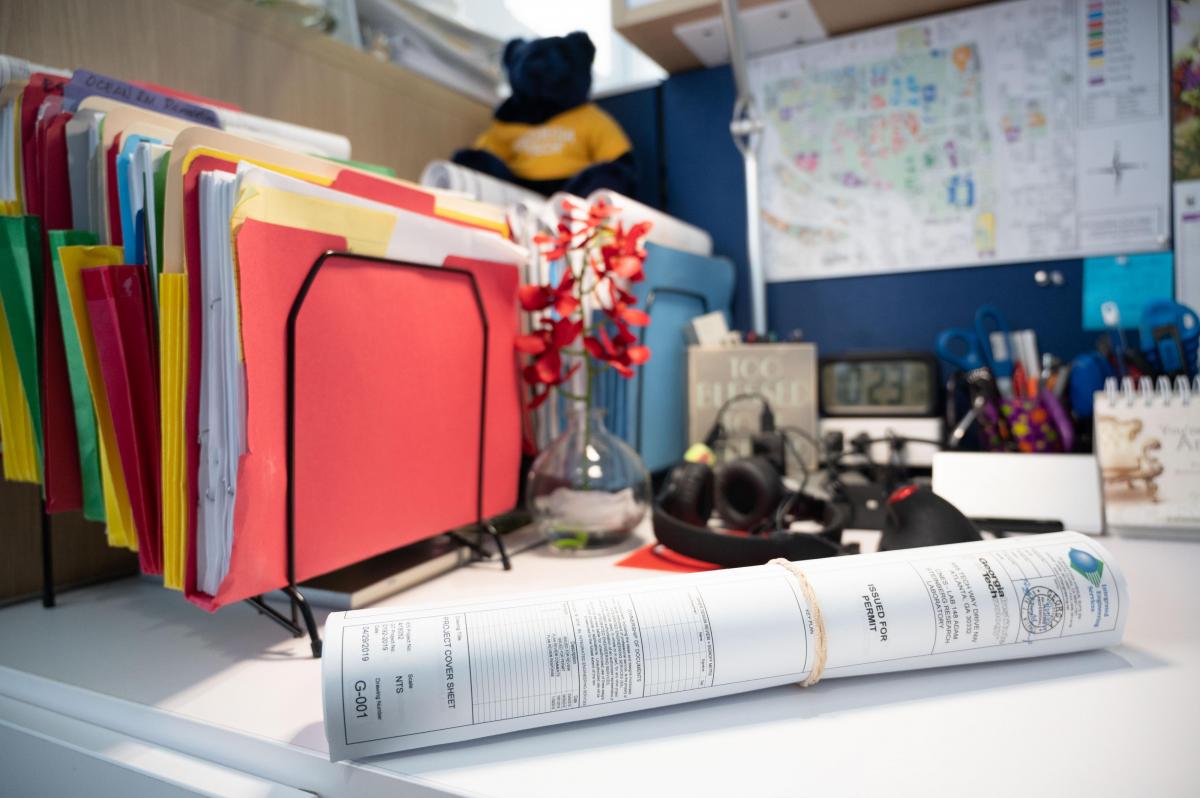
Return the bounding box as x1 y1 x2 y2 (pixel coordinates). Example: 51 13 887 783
0 525 1200 798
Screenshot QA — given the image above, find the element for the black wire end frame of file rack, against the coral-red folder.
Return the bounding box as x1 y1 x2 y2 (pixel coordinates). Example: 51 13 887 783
270 251 512 658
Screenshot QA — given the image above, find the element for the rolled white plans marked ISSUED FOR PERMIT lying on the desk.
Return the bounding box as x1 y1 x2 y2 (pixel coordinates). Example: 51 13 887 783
323 532 1129 761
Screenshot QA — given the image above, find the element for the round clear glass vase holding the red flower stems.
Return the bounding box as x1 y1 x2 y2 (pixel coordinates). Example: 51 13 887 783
526 406 650 552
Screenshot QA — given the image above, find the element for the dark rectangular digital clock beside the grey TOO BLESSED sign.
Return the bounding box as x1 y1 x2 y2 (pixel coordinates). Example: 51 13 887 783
820 352 941 416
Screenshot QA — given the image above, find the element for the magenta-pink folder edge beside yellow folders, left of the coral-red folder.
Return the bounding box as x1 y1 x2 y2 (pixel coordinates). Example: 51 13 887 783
82 265 162 574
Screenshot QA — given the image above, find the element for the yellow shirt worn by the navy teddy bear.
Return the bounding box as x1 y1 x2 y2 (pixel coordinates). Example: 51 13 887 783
475 103 630 180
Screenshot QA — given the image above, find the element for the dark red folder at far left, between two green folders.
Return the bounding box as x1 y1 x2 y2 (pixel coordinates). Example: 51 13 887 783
32 96 83 512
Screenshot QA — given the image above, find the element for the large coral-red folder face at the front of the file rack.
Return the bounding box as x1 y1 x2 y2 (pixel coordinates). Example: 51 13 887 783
187 220 521 608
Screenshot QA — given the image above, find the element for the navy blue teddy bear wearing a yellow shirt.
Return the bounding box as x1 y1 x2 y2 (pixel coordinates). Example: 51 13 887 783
454 31 636 197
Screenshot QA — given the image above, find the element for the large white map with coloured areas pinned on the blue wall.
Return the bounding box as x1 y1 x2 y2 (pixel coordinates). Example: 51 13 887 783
749 0 1170 281
